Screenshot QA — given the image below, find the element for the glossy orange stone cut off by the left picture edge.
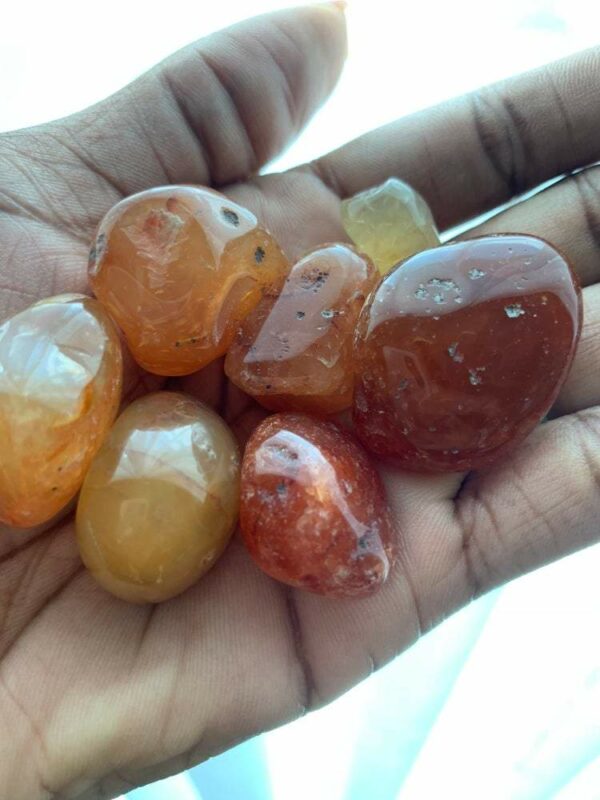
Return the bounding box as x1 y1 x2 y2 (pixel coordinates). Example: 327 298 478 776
0 295 122 528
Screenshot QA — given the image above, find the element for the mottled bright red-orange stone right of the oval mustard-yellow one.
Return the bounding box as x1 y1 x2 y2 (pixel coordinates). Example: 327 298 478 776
240 413 395 597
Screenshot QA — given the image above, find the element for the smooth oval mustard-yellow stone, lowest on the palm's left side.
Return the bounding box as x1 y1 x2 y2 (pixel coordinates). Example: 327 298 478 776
77 392 239 603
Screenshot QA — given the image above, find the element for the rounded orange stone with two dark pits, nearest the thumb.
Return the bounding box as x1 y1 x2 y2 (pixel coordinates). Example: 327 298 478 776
89 186 288 375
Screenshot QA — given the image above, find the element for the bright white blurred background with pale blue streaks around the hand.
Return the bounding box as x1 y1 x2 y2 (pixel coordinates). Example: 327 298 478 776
0 0 600 800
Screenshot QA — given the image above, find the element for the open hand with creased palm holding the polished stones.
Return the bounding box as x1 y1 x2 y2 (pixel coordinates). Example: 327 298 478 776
0 4 600 800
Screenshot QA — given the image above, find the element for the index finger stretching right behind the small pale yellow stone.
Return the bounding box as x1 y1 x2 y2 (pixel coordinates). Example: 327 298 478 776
311 48 600 229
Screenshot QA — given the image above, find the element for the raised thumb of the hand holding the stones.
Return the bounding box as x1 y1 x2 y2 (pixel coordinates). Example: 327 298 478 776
55 3 346 194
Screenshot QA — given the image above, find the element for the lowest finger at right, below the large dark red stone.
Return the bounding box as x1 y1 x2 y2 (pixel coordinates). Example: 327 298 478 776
456 408 600 594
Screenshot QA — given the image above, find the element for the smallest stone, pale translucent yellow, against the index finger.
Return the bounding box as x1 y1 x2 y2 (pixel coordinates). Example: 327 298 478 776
342 178 440 275
